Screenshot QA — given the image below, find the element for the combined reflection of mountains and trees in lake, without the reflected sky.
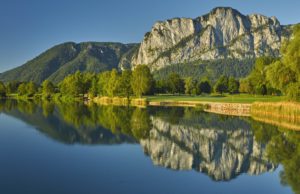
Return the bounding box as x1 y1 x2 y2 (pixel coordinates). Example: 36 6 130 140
0 100 300 193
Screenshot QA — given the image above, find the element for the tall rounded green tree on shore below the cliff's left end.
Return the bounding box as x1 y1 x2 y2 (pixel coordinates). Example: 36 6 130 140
131 65 153 97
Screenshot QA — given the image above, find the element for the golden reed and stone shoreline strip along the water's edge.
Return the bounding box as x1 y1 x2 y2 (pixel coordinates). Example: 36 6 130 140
2 97 300 131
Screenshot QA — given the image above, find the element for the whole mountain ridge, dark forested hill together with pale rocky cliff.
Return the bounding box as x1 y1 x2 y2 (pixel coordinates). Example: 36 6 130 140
0 7 293 83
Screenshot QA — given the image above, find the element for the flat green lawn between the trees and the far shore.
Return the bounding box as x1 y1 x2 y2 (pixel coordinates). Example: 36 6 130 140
146 94 285 103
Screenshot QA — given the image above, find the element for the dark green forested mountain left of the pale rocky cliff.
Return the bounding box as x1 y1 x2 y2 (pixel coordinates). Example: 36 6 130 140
0 42 137 83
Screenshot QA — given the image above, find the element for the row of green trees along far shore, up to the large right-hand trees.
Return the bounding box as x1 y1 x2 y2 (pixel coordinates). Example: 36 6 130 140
0 65 239 98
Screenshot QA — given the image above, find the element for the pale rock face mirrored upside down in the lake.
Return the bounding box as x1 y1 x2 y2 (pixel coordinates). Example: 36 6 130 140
140 117 276 181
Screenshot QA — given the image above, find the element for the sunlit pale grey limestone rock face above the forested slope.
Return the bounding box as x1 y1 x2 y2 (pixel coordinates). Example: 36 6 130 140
131 7 289 69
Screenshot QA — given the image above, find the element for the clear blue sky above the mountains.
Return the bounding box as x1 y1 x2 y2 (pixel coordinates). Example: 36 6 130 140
0 0 300 72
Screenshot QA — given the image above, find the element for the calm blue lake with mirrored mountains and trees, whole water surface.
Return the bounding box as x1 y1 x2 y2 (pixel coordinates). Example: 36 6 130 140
0 100 300 194
